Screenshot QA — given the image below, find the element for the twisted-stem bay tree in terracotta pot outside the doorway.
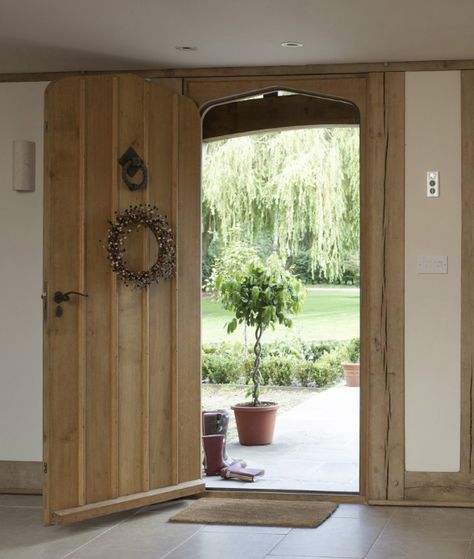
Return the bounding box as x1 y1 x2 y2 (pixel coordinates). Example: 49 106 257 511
213 255 304 445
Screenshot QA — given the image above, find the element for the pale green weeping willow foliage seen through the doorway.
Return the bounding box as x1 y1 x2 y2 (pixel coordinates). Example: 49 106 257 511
203 127 360 281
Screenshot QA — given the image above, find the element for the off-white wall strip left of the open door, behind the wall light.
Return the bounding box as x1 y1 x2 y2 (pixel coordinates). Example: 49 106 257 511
0 83 46 460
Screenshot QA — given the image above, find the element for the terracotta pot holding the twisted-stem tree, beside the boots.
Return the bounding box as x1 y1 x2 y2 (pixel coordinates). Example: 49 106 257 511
232 402 278 446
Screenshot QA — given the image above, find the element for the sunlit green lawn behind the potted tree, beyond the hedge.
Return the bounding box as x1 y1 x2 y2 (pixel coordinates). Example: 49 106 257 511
202 288 360 343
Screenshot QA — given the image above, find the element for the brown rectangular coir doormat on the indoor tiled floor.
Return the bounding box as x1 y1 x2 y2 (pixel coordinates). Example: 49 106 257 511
169 497 337 528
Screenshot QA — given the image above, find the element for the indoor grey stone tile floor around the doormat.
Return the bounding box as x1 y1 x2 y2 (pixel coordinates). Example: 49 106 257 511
0 495 474 559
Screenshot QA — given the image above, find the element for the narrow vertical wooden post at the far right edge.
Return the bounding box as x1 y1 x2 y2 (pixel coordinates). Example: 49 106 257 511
461 70 474 474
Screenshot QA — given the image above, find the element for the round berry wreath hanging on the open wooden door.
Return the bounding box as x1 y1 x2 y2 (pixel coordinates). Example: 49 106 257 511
106 204 176 288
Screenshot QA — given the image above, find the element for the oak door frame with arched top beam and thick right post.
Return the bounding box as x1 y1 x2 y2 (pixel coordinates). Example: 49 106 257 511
183 72 405 502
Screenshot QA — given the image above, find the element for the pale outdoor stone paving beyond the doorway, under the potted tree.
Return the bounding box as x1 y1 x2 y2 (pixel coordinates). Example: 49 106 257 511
204 385 359 493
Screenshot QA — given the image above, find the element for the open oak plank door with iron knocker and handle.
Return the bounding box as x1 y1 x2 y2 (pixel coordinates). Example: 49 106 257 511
44 75 204 524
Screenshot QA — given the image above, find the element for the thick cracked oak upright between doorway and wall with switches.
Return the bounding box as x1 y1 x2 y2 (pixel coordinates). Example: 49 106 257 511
366 74 404 500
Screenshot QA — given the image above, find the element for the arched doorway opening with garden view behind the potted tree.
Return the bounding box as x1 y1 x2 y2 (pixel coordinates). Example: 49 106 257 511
202 91 361 494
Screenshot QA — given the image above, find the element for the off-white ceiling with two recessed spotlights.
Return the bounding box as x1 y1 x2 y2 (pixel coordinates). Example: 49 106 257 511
0 0 474 73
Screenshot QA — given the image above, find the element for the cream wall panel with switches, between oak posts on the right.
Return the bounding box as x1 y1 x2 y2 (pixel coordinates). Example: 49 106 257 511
405 72 461 472
